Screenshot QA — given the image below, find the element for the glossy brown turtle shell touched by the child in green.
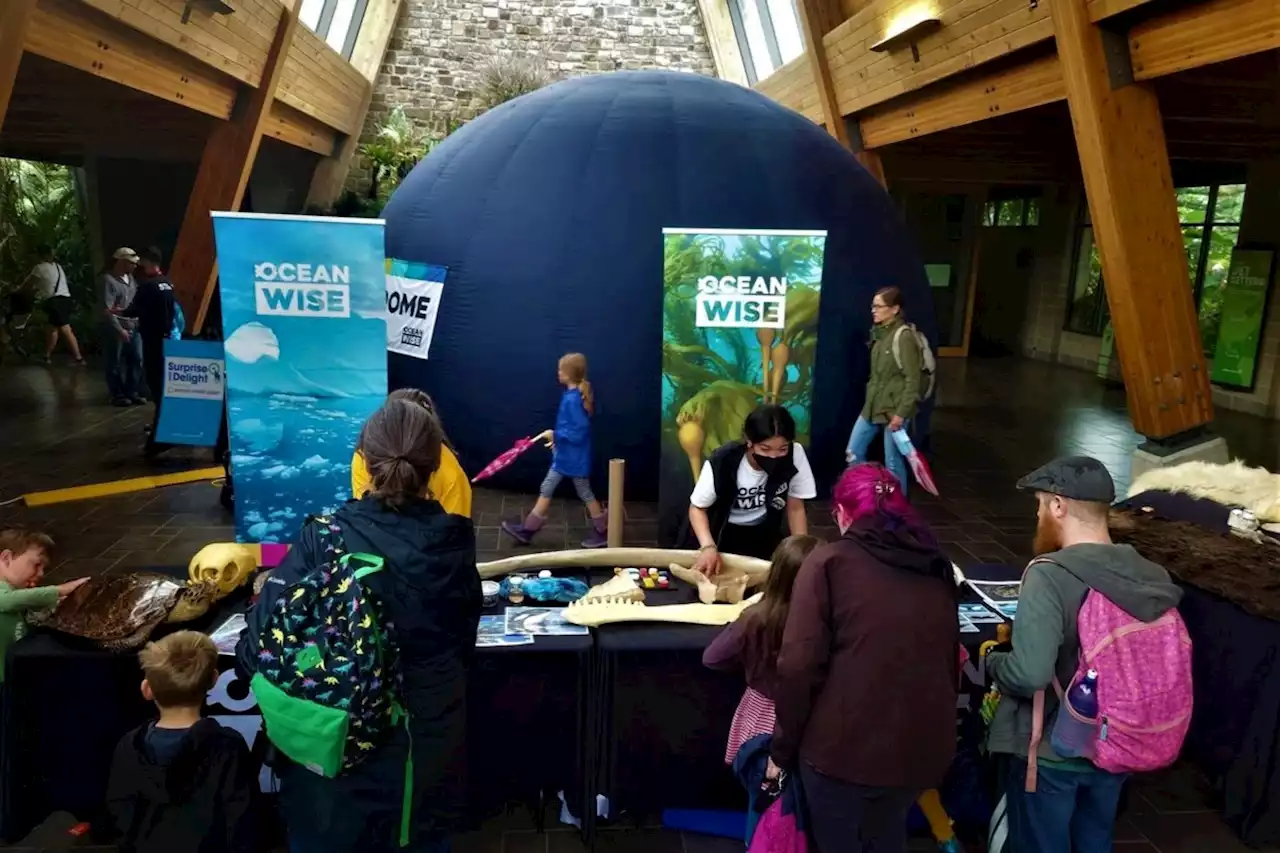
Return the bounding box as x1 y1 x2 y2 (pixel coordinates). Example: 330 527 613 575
32 571 186 648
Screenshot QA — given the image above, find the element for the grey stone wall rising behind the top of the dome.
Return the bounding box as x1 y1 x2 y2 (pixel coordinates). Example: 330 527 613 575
347 0 716 190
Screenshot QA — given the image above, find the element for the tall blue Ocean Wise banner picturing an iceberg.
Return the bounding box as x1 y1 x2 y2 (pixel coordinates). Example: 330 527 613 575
212 213 387 543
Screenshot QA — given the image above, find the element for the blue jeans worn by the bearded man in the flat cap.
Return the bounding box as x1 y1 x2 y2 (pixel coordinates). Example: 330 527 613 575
1005 758 1128 853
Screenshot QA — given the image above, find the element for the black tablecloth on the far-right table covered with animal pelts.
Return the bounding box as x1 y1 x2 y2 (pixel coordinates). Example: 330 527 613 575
1126 492 1280 847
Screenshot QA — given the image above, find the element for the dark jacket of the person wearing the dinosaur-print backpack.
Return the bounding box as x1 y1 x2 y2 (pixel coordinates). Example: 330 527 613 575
237 497 481 853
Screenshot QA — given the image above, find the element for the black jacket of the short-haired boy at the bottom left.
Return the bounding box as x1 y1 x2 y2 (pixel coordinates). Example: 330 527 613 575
106 720 257 853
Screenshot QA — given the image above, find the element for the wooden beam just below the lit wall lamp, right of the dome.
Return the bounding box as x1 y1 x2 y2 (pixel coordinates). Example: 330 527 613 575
858 55 1066 149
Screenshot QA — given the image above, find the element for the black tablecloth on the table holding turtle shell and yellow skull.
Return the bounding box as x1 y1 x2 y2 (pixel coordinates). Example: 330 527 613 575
0 569 593 839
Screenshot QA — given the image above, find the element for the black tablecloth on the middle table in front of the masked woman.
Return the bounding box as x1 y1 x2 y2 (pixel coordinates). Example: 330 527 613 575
595 565 1019 815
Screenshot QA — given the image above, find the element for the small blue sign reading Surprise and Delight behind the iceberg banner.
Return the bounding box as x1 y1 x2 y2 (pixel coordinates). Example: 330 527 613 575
156 338 227 447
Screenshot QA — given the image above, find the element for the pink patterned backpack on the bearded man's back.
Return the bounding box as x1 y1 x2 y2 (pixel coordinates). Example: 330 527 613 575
1027 560 1192 792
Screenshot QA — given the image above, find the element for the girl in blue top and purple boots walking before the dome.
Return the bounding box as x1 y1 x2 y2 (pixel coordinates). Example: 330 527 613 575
502 352 608 548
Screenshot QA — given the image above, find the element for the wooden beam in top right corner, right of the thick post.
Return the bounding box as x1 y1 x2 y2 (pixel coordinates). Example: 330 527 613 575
1129 0 1280 81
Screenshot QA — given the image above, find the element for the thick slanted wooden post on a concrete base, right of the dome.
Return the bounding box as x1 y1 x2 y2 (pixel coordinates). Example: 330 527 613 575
1050 3 1213 439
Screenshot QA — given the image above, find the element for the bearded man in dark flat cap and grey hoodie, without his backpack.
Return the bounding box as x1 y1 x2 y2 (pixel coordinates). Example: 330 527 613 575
987 456 1181 853
